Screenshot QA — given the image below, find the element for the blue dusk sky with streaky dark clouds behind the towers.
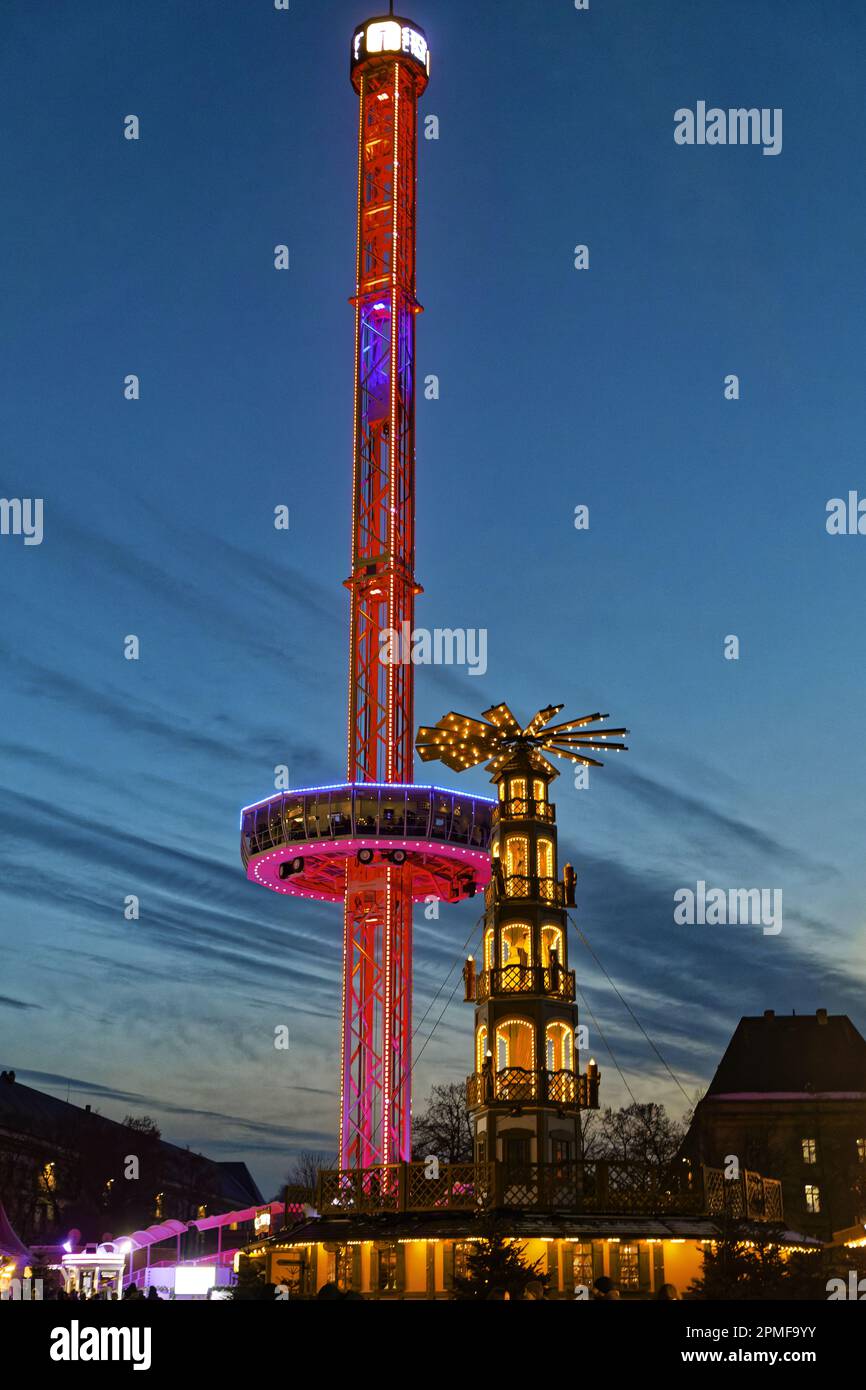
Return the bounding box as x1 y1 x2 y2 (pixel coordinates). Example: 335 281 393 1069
0 0 866 1195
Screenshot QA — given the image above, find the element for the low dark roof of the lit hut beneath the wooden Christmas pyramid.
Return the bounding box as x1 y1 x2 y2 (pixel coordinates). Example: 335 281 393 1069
262 1211 822 1248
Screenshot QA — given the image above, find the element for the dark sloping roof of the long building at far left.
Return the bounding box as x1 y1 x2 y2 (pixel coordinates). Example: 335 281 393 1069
0 1073 263 1208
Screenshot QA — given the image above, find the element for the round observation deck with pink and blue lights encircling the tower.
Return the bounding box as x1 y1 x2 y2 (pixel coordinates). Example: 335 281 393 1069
240 783 496 902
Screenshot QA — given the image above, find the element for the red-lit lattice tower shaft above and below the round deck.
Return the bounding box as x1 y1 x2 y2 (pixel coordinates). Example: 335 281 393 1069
341 17 428 1168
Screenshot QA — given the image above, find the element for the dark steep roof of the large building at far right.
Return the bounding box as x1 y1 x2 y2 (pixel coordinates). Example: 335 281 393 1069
706 1009 866 1098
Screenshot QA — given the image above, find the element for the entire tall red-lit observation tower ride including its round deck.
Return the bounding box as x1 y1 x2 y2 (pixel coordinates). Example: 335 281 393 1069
242 14 492 1182
